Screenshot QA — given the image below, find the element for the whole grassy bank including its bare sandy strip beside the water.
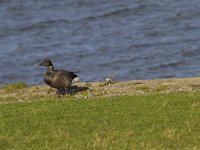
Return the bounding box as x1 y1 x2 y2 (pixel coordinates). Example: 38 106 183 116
0 78 200 150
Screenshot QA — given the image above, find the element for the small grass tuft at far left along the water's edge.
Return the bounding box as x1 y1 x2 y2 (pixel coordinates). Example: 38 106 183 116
1 82 28 92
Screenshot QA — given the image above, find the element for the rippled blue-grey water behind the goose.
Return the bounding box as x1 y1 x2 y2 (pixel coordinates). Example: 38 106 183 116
0 0 200 85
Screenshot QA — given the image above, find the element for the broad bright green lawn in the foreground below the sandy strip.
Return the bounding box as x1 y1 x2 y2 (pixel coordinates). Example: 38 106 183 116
0 92 200 150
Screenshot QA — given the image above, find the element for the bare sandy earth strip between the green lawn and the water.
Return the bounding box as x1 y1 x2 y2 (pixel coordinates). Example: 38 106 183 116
0 77 200 104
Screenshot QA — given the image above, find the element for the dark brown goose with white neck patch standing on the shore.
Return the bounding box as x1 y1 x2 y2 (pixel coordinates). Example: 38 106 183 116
39 59 79 95
